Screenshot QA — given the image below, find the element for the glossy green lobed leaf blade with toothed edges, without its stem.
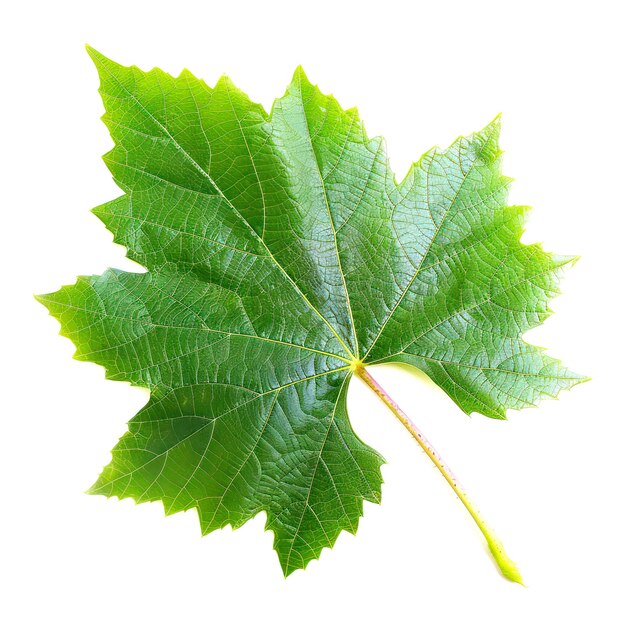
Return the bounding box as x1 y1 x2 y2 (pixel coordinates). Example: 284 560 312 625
39 48 583 575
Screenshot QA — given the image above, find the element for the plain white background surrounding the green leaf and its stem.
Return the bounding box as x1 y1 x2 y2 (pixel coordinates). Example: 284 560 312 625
0 0 626 626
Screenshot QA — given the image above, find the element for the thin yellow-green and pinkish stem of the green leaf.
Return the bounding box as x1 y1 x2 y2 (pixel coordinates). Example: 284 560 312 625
354 364 524 585
